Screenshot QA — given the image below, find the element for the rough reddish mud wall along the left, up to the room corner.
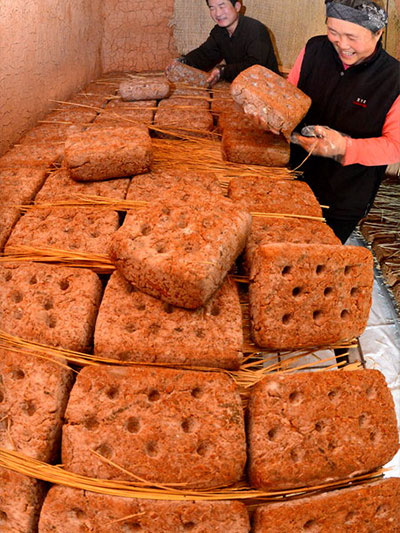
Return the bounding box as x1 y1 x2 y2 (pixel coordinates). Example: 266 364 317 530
0 0 104 154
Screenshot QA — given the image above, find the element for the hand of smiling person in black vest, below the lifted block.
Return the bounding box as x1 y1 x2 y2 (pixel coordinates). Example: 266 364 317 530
290 126 346 162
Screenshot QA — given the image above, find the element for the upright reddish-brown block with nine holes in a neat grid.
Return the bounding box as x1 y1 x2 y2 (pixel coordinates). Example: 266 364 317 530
249 243 373 350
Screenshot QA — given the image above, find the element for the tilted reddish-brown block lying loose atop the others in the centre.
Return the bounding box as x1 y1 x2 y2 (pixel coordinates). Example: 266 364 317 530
110 187 251 309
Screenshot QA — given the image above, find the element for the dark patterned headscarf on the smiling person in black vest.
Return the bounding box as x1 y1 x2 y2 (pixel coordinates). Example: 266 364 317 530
325 0 388 33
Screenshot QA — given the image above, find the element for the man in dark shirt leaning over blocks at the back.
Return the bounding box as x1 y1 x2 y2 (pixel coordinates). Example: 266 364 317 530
171 0 278 85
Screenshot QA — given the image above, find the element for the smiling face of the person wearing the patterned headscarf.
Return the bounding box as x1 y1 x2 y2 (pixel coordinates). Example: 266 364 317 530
326 18 382 65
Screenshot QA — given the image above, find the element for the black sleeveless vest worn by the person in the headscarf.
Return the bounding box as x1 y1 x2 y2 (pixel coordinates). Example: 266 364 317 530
291 36 400 220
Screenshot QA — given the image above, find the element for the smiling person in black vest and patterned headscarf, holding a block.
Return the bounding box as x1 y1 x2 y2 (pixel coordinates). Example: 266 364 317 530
288 0 400 242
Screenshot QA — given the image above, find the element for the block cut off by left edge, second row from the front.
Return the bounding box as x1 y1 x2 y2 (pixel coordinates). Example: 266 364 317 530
0 348 72 462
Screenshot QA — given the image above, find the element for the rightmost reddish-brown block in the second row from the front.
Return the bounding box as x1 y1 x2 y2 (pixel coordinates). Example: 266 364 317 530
247 370 399 490
